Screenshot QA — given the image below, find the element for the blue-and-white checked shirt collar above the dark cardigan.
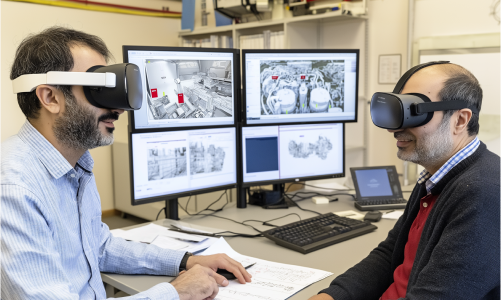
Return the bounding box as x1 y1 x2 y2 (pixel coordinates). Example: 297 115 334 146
418 137 480 195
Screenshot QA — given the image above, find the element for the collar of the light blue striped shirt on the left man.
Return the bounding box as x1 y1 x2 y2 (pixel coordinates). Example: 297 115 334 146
18 121 94 179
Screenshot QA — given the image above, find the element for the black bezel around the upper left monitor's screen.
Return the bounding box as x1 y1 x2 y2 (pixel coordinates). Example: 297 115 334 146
122 45 241 133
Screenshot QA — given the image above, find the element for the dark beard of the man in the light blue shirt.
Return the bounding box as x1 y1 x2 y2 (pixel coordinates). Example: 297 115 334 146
53 92 118 150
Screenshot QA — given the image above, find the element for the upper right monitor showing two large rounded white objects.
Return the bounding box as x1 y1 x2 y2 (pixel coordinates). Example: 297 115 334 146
242 49 359 125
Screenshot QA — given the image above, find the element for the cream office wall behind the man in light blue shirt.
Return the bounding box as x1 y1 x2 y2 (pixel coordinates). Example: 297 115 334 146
0 1 181 210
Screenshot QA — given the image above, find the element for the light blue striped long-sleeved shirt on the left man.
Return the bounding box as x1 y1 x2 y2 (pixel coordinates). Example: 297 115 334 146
0 121 185 300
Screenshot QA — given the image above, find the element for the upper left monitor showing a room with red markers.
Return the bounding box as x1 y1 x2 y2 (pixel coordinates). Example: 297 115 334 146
123 46 240 131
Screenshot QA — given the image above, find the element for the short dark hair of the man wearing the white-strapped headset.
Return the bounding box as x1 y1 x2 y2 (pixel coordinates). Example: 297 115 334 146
10 26 112 119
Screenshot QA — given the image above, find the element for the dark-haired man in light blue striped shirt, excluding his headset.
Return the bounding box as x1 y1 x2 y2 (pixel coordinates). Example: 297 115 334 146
0 27 251 300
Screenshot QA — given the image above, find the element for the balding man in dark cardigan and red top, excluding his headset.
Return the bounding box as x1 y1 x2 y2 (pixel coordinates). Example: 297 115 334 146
310 63 501 300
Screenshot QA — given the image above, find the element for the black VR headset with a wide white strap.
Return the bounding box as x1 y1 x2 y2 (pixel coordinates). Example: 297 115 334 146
12 63 143 110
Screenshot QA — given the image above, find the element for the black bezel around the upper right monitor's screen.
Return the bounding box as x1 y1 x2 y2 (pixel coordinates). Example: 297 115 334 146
241 49 360 126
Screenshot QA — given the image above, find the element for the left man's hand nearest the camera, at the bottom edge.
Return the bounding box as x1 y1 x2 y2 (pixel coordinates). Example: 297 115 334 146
171 265 228 300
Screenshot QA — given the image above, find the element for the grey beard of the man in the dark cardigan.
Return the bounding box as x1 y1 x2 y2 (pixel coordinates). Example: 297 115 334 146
394 115 454 167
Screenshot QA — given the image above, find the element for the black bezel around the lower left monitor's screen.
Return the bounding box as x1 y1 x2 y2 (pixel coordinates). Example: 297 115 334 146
128 126 240 206
